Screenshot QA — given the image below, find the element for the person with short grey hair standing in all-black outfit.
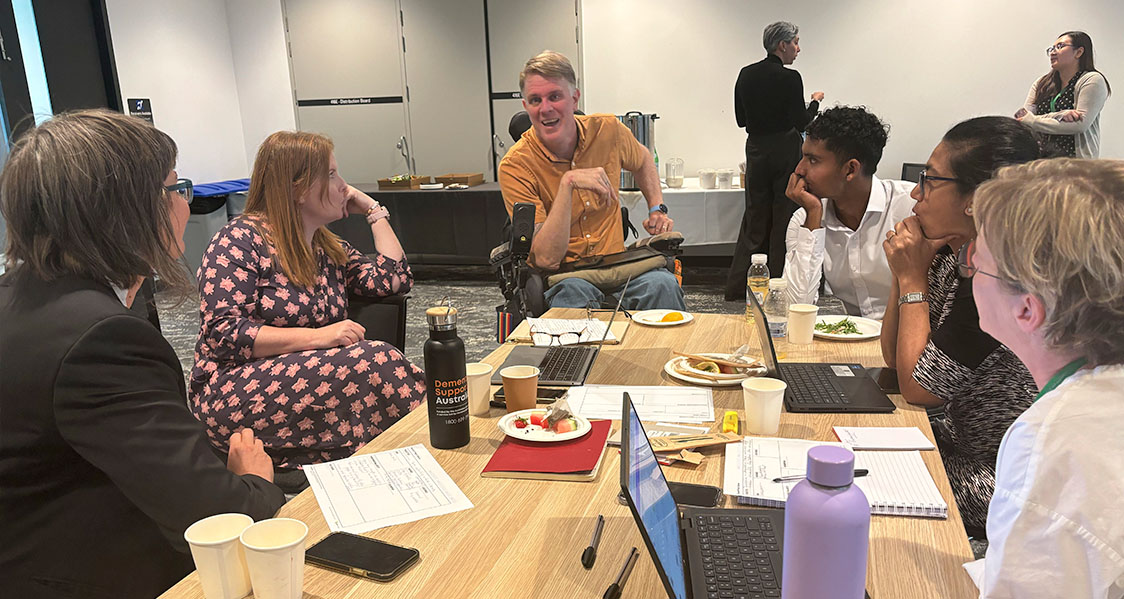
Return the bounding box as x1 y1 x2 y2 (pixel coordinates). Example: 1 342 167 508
726 21 824 301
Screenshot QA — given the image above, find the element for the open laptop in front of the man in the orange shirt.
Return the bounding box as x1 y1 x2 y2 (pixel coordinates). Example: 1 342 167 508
491 276 632 387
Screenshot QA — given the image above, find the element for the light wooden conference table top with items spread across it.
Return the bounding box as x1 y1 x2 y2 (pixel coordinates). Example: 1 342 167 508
162 310 977 599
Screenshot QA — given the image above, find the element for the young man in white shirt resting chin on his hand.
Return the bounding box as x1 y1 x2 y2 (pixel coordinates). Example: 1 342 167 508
783 106 915 319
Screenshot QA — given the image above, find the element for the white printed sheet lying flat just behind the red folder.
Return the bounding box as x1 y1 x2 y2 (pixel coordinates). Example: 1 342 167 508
566 384 714 423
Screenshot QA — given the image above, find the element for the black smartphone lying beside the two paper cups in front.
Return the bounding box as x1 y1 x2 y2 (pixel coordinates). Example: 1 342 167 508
305 533 422 582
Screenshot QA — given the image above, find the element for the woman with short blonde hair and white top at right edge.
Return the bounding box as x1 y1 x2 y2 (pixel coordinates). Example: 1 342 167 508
959 158 1124 599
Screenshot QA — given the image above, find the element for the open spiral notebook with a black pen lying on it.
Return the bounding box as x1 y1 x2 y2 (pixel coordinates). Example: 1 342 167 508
723 437 949 518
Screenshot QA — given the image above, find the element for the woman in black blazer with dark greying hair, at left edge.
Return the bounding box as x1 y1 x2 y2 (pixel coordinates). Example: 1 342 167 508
0 110 284 599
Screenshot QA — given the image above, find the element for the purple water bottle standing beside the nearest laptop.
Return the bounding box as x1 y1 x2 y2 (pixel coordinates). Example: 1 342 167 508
781 445 870 599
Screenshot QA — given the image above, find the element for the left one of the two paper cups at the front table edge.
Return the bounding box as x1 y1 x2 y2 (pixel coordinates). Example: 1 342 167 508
183 514 254 599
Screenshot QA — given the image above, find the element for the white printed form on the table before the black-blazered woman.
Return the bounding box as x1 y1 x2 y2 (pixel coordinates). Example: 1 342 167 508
305 444 472 534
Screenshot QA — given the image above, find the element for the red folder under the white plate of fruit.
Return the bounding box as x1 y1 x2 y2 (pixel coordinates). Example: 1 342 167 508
480 420 613 481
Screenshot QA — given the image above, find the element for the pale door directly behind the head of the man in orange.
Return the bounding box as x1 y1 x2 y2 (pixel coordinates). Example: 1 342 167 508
484 0 581 168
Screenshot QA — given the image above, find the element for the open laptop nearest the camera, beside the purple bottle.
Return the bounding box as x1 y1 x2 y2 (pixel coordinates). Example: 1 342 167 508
620 393 785 599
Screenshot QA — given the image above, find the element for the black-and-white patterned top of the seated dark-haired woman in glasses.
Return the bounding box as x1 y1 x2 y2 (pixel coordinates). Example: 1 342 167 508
914 246 1037 528
